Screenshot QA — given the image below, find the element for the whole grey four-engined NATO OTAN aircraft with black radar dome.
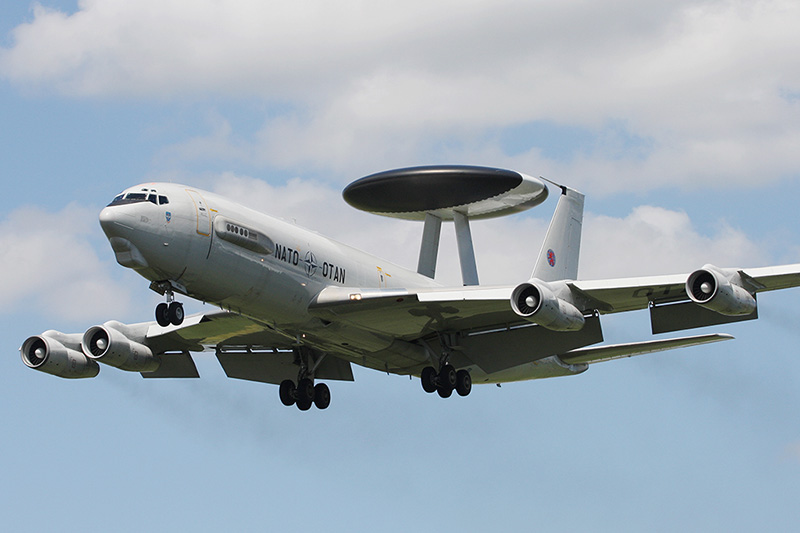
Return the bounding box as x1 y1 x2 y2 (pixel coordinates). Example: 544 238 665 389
20 166 800 410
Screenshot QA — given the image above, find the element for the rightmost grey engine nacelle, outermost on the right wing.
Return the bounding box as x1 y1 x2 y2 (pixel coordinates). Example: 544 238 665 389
686 265 756 316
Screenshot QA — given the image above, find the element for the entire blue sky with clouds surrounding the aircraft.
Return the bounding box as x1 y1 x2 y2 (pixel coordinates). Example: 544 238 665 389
0 0 800 531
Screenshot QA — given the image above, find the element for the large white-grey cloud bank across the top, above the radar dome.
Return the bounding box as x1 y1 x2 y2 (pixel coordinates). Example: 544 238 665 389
0 0 800 193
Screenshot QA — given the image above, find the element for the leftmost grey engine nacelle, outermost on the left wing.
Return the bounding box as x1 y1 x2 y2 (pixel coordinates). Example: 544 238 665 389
19 330 100 379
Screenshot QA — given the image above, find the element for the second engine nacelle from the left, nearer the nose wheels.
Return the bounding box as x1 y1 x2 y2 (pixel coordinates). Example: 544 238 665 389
81 323 161 372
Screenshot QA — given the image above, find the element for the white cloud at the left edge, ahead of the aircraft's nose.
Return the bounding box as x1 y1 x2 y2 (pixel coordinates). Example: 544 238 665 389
0 204 132 321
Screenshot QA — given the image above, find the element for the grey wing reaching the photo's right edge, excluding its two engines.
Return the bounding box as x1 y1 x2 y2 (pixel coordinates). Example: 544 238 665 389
309 264 800 340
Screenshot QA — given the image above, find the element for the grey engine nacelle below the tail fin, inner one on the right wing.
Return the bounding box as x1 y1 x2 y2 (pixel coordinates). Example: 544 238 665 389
511 280 585 331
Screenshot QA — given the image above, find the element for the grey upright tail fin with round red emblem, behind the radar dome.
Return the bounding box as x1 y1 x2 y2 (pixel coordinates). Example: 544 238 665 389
532 180 584 281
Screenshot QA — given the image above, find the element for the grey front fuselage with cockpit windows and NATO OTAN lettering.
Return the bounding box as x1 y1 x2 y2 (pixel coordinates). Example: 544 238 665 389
100 183 438 374
